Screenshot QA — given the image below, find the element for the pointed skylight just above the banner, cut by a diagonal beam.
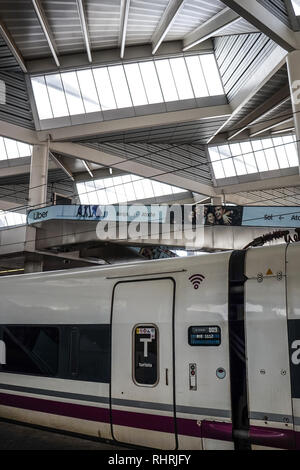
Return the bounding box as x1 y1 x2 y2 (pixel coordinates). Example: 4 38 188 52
77 175 185 204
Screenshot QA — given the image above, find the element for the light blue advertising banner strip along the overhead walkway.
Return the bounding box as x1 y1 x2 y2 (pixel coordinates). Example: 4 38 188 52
27 204 300 228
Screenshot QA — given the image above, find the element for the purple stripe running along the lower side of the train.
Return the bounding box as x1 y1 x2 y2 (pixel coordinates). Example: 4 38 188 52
0 393 300 449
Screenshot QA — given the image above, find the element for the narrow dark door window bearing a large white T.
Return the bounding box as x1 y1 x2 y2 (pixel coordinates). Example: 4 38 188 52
133 324 158 387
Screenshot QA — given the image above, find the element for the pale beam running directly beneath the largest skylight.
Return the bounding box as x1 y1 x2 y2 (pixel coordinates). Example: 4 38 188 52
37 104 232 142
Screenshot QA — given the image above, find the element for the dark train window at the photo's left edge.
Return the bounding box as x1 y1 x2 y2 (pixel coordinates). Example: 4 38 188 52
1 326 59 377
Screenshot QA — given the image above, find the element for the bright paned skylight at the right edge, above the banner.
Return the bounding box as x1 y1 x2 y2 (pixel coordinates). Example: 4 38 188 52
208 135 299 179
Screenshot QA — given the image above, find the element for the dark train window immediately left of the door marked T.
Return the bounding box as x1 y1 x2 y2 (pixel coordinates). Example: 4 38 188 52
71 325 110 383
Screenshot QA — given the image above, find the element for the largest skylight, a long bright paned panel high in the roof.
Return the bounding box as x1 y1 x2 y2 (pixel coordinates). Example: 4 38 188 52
31 54 224 120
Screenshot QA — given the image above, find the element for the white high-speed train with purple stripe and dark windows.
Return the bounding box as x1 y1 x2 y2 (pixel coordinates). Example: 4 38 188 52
0 243 300 450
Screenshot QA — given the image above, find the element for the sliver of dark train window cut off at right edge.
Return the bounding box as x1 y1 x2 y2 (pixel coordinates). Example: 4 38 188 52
288 320 300 398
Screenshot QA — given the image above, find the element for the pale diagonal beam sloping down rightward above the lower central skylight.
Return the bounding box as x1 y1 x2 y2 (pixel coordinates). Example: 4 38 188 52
50 142 215 196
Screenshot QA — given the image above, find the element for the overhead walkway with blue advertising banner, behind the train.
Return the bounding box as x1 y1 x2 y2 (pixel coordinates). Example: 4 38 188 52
0 205 300 272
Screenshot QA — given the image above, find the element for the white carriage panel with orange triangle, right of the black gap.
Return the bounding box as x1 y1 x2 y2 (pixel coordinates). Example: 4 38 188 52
245 245 293 448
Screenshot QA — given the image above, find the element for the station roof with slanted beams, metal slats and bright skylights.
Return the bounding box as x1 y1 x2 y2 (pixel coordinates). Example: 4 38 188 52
0 0 300 209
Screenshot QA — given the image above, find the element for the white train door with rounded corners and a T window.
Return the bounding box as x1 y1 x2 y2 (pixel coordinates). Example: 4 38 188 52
111 278 177 450
